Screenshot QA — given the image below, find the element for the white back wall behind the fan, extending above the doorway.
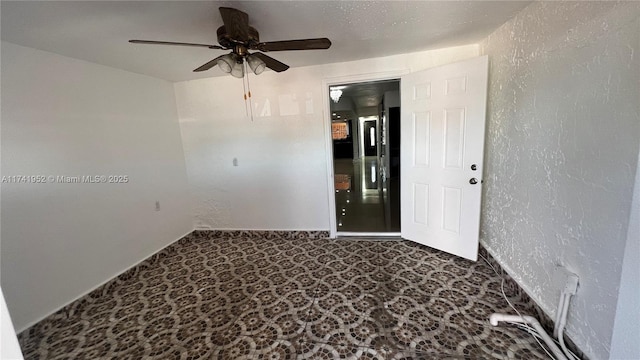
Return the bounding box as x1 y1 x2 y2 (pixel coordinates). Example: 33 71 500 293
175 45 478 230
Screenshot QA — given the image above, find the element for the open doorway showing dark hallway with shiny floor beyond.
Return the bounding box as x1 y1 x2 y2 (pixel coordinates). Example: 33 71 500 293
328 79 400 236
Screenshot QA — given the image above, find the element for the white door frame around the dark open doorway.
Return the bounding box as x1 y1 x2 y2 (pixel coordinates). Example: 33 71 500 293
322 69 411 239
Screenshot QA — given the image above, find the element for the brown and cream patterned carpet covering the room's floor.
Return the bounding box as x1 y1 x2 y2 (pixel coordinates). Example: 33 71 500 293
19 232 547 360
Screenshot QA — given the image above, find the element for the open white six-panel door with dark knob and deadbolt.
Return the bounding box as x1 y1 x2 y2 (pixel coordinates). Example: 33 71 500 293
400 56 488 261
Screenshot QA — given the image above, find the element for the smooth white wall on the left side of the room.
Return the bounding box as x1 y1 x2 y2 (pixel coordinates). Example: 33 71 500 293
1 42 192 331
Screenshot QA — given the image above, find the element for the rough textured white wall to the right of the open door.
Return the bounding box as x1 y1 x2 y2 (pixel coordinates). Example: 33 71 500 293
481 2 640 359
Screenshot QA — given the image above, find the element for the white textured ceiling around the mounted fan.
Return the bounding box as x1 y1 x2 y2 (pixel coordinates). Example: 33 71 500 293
0 1 529 81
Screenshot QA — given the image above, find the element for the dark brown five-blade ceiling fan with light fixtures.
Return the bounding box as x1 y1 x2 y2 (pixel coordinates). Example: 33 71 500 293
129 7 331 78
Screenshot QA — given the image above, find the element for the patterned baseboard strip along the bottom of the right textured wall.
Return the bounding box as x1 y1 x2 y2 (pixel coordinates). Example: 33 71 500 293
479 243 589 360
